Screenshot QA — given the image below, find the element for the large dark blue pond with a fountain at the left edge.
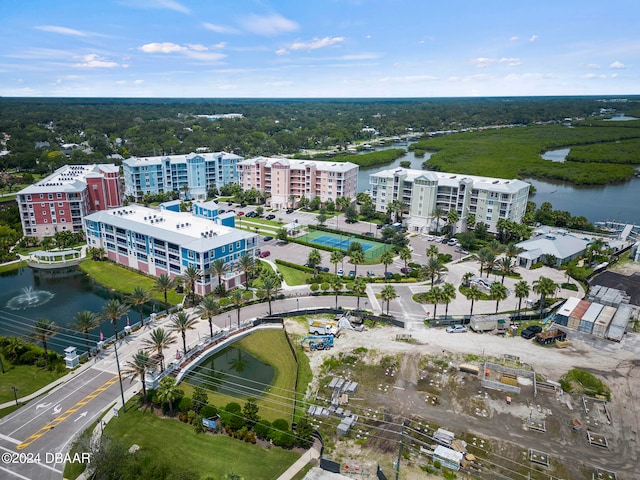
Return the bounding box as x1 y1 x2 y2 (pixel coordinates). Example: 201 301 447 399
0 267 159 353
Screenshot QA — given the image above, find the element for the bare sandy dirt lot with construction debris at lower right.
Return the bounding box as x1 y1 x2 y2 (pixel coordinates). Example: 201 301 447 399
287 322 640 480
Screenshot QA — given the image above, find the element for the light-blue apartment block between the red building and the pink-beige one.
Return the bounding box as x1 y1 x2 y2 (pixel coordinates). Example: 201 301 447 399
122 152 243 200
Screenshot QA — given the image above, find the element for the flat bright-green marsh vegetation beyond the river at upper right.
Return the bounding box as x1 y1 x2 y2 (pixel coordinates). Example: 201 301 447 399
411 125 640 184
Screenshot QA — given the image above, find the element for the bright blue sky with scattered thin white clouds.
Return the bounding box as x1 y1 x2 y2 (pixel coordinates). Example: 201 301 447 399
0 0 640 98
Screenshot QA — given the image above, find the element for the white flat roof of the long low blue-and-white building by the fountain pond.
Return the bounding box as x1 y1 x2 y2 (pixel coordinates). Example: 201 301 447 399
85 205 257 252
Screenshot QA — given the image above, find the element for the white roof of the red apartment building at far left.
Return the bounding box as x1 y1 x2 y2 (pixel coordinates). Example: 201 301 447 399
18 163 120 194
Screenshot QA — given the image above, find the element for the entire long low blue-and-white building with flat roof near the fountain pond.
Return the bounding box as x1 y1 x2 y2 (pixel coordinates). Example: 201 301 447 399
84 205 259 295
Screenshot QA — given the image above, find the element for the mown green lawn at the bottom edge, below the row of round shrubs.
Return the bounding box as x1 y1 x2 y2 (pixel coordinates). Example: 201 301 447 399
105 408 300 480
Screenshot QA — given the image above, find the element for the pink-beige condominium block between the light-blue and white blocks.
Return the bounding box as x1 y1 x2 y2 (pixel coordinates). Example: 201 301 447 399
237 157 358 209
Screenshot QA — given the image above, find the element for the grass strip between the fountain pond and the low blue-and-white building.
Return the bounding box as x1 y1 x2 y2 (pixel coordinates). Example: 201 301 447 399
80 260 184 305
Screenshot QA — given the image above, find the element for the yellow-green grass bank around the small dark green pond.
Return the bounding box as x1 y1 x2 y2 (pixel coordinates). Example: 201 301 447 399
180 330 298 422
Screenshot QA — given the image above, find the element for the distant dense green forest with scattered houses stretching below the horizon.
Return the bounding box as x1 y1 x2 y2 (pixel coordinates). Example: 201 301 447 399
0 97 624 173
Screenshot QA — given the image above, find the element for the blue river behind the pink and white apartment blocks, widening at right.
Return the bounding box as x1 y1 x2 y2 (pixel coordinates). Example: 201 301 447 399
358 145 640 225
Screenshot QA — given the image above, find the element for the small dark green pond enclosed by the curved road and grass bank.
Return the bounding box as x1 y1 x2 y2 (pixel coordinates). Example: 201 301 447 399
185 347 275 397
